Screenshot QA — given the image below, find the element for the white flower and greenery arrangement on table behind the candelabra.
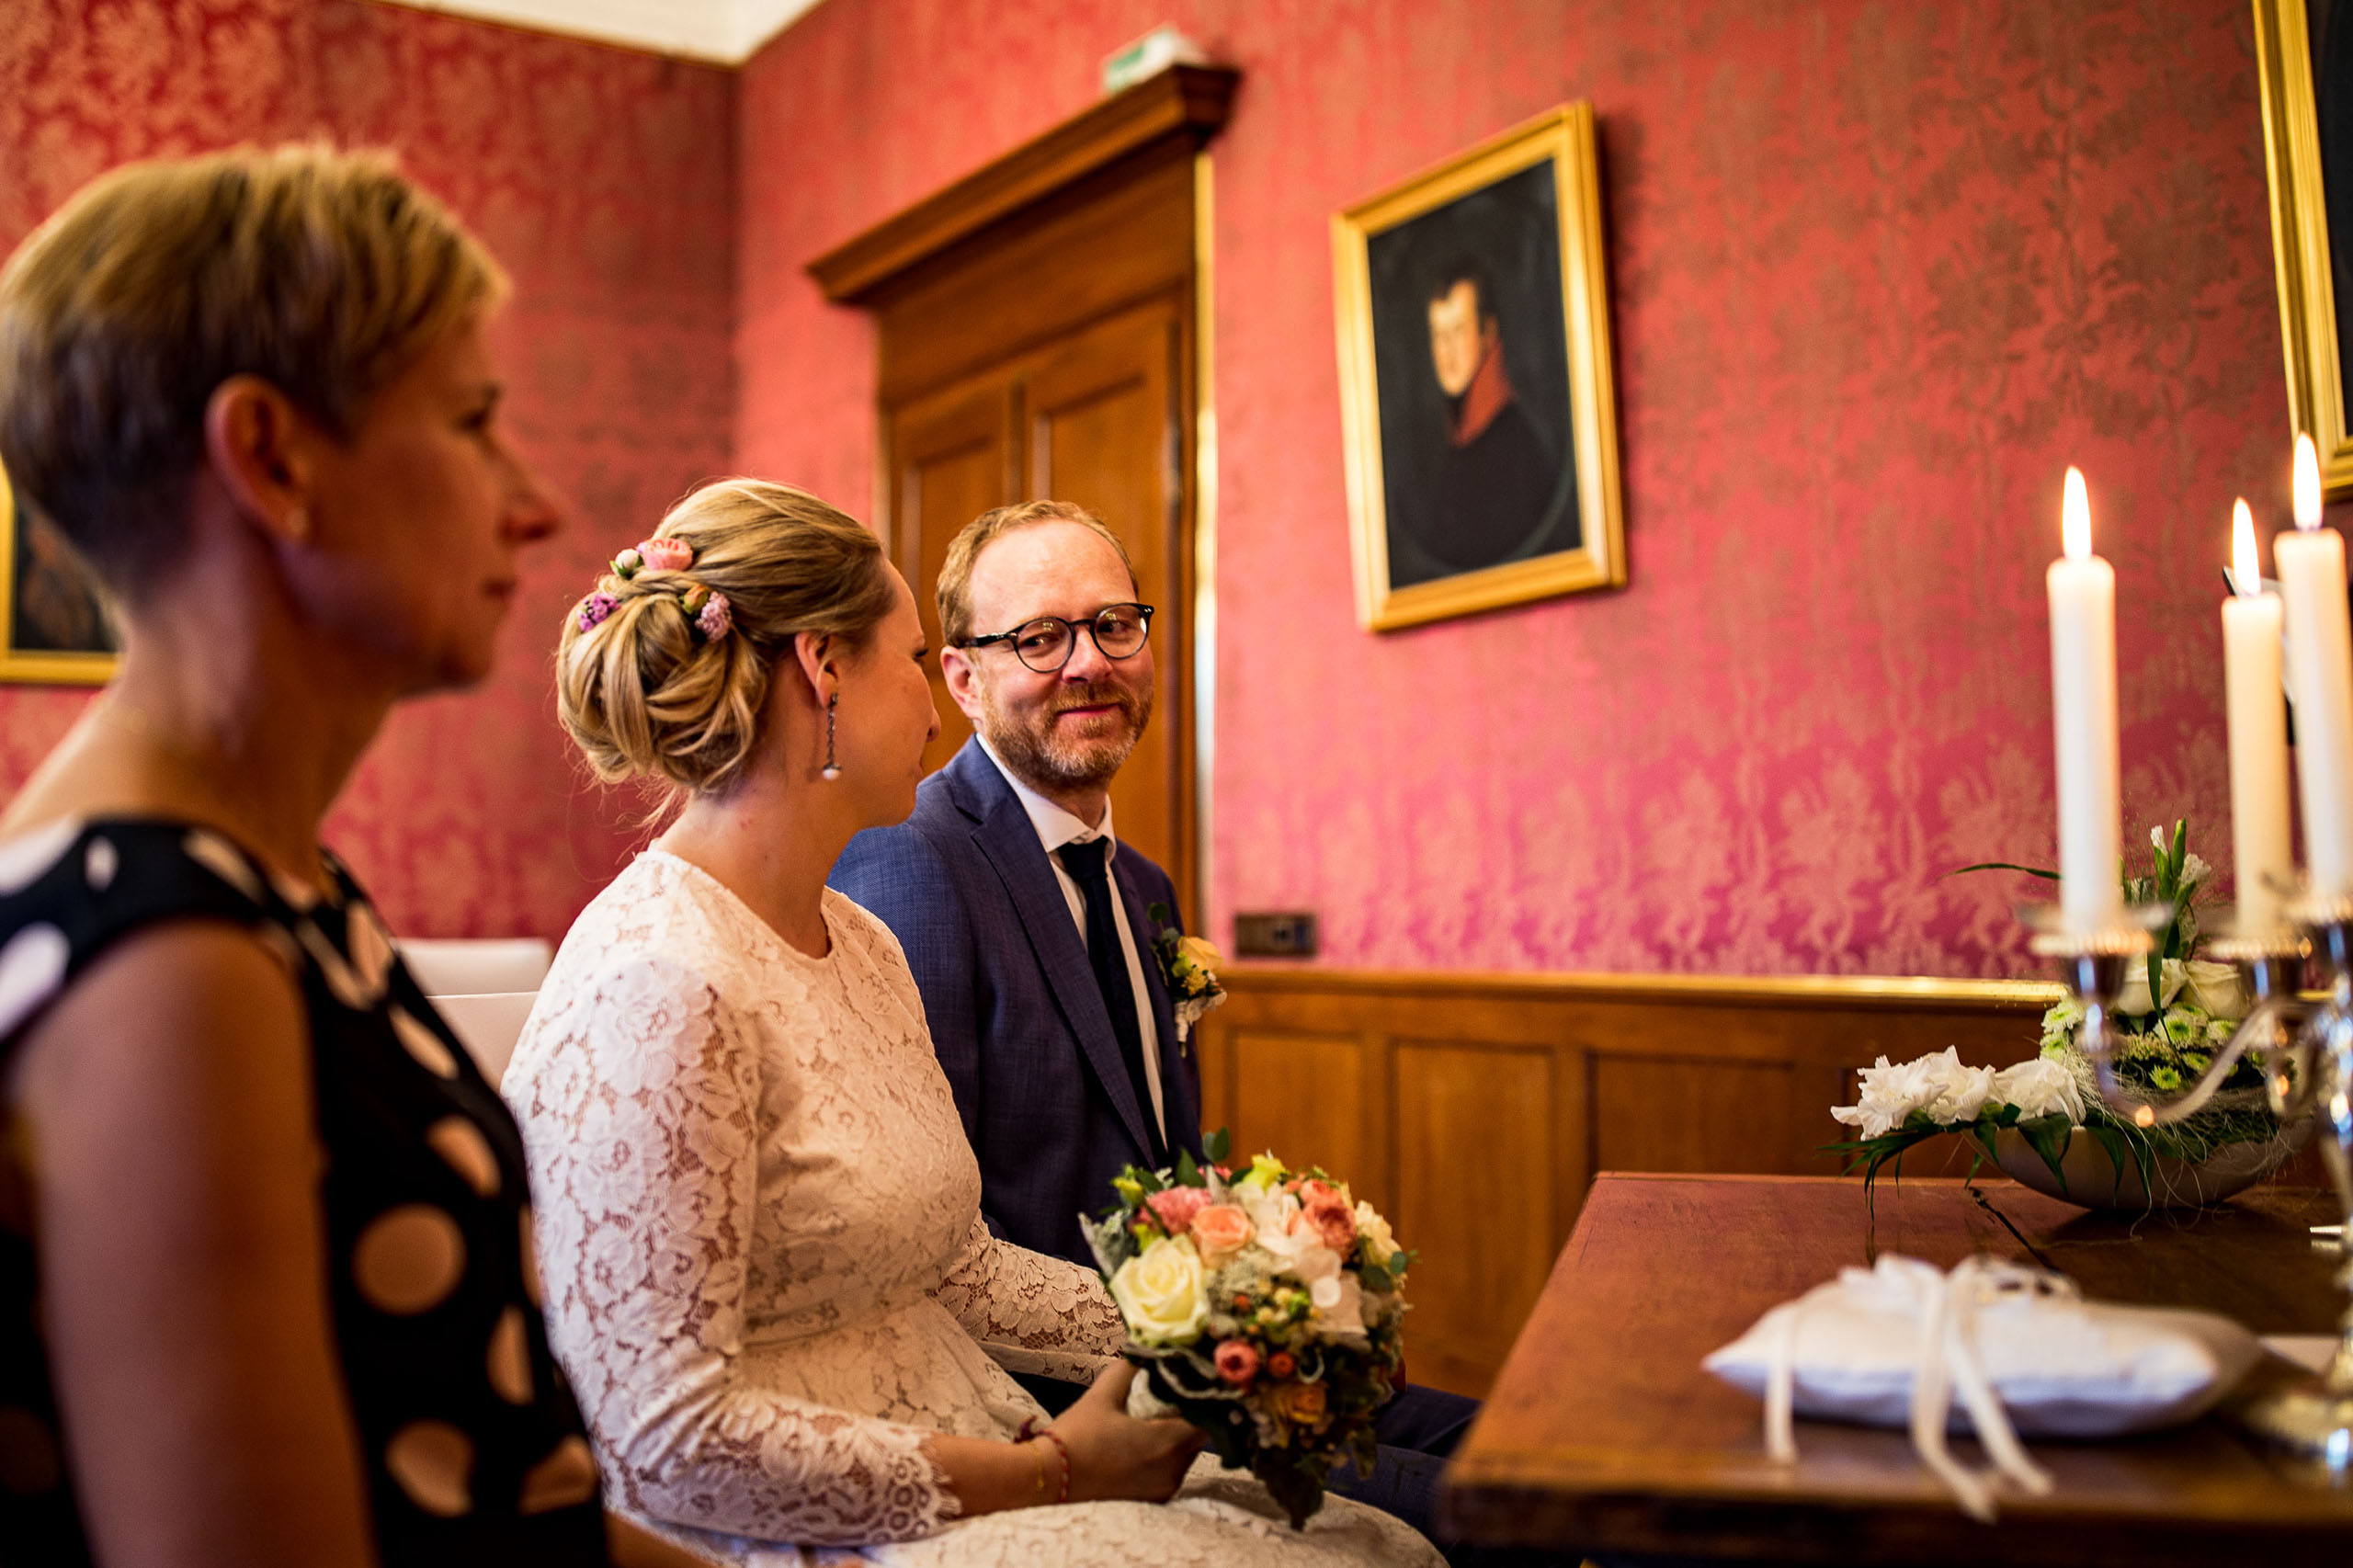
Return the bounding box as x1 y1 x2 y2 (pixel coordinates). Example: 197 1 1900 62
1831 822 2280 1187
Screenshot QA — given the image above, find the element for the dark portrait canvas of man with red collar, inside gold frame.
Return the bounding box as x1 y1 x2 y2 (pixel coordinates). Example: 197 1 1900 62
1365 163 1584 588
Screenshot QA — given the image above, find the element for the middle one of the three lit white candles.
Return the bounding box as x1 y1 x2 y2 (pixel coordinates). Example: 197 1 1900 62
2222 502 2290 937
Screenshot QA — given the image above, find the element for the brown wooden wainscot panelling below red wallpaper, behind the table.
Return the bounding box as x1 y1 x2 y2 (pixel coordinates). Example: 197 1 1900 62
1195 968 2056 1393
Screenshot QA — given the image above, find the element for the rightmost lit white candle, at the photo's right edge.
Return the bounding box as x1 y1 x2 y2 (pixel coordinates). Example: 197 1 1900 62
2270 436 2353 897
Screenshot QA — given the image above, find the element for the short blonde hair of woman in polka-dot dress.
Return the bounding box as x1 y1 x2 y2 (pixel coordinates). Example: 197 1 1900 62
0 146 506 598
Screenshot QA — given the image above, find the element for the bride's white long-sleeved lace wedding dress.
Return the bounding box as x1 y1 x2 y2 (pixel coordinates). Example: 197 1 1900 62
504 850 1440 1568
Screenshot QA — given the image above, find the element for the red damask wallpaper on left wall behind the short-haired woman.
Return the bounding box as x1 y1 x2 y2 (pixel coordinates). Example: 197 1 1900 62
0 0 736 937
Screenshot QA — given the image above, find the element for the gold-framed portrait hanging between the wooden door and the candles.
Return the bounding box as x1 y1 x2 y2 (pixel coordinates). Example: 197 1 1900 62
1332 104 1626 631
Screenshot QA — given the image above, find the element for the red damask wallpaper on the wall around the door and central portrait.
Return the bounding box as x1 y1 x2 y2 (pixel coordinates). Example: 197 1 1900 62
736 0 2287 974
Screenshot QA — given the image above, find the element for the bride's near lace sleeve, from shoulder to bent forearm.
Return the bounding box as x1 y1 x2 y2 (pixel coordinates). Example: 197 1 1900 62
516 956 958 1544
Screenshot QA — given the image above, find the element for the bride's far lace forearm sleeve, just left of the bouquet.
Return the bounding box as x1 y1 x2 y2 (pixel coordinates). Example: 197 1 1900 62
932 1215 1127 1382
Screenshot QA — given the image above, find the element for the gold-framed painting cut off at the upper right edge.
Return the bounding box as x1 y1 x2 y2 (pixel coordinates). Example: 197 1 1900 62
2254 0 2353 502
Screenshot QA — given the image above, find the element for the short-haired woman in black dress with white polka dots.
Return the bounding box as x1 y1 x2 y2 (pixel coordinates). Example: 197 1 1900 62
0 148 680 1568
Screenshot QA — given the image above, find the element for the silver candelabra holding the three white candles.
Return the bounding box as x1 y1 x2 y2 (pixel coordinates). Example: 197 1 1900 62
2033 897 2353 1469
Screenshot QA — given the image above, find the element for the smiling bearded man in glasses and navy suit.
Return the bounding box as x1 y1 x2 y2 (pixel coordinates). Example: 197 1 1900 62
833 502 1478 1530
